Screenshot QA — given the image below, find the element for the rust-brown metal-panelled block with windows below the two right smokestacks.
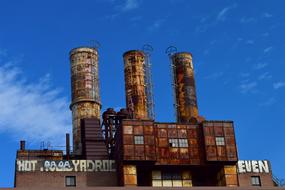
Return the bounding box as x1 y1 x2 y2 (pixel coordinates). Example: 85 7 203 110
113 119 238 186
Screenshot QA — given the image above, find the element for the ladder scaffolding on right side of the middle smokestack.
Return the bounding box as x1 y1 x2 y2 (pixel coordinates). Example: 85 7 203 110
142 44 155 120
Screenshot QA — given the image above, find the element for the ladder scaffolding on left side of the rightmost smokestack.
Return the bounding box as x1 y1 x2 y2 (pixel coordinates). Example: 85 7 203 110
165 46 179 120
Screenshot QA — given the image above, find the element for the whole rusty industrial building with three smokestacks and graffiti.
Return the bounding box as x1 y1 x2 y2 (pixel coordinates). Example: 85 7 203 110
12 47 274 188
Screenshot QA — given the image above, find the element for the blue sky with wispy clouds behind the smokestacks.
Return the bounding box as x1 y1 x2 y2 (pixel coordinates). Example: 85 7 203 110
0 0 285 187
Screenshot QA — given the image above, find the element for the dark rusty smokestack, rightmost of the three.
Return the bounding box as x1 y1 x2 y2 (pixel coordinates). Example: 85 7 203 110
171 52 198 123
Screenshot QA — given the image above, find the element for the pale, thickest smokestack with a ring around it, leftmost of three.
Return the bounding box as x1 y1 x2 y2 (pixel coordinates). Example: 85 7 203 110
70 47 101 155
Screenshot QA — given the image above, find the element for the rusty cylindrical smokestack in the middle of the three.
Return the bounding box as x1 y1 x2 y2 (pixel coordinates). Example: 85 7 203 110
123 50 148 119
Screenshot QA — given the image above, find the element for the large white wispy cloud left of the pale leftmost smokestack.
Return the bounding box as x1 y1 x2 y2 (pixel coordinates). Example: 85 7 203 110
0 65 71 145
